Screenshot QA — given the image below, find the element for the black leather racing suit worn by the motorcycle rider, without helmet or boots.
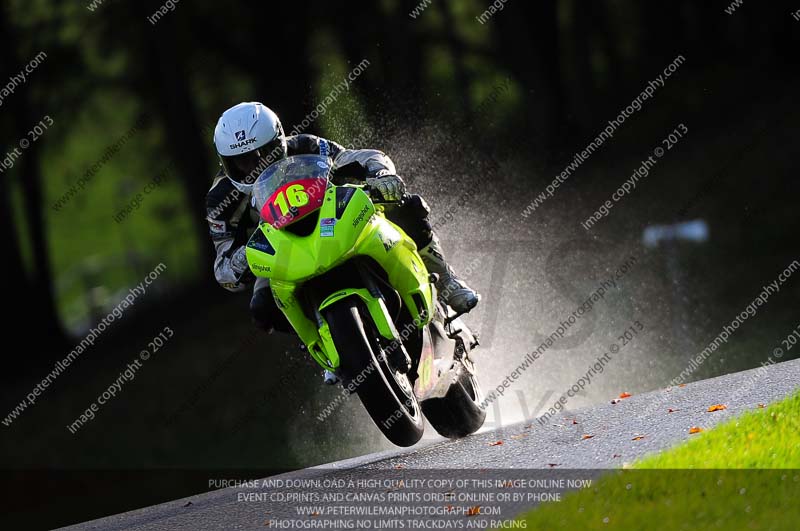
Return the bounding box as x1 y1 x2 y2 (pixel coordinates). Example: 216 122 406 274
206 135 433 331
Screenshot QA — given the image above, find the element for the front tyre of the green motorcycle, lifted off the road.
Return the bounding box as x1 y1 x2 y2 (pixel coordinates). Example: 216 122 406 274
323 297 425 446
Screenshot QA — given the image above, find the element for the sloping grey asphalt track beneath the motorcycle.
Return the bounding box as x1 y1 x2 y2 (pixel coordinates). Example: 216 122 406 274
68 360 800 530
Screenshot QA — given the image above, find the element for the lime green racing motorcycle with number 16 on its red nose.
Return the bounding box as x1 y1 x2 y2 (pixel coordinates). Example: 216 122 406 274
246 155 486 446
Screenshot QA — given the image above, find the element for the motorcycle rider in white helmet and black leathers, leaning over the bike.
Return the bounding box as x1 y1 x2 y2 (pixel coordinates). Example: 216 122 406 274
206 102 480 332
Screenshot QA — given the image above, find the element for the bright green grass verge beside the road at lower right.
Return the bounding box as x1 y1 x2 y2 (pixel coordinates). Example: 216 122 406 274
523 393 800 530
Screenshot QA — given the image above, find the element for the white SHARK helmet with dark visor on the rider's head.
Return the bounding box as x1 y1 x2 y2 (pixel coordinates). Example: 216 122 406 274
214 102 287 192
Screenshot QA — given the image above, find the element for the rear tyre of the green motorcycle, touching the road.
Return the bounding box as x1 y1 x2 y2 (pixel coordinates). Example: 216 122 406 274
421 365 486 439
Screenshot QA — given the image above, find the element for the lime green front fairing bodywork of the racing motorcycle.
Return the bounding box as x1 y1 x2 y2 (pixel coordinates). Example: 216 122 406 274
246 184 434 369
